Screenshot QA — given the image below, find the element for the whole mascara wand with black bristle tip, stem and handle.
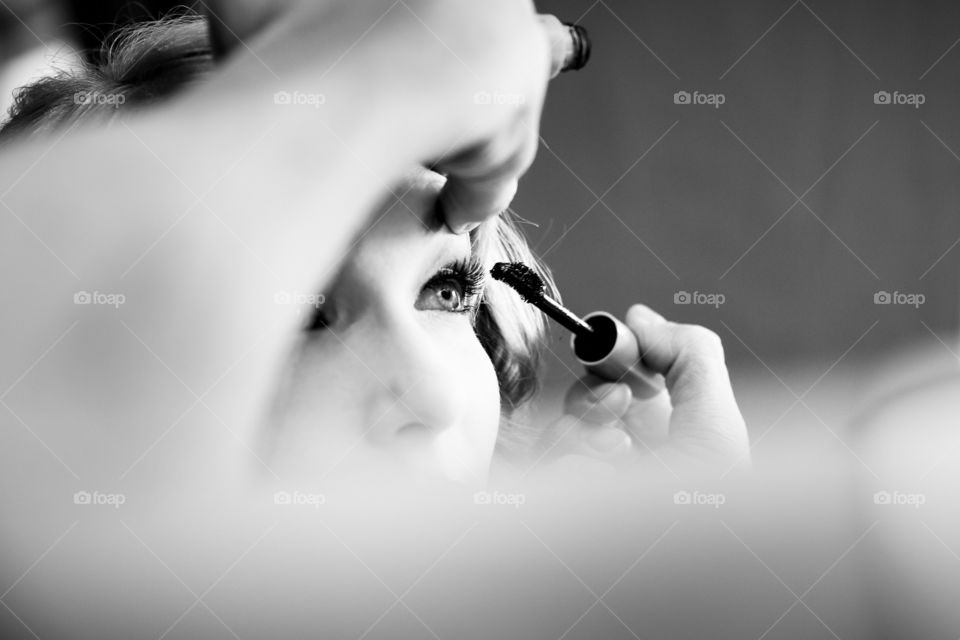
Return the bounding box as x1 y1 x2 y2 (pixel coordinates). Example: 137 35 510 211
490 262 664 398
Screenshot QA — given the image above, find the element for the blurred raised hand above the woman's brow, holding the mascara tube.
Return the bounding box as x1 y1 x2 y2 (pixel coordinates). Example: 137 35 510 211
207 0 569 232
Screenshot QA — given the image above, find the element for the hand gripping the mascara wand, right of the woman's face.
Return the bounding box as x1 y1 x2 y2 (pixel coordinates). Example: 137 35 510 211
548 305 750 475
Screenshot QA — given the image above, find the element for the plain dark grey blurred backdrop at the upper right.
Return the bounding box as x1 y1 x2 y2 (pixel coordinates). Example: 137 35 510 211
514 0 960 396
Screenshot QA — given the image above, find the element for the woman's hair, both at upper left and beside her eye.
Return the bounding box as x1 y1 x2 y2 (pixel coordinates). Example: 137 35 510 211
0 14 556 444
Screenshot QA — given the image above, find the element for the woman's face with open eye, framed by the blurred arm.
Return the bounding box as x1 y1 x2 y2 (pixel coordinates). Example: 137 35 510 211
271 171 500 484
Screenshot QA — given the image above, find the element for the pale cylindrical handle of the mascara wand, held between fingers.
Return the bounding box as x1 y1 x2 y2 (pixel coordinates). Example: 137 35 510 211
570 311 666 399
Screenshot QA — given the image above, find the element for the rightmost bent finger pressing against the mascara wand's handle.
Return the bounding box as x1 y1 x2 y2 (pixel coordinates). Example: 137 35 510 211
626 305 747 457
